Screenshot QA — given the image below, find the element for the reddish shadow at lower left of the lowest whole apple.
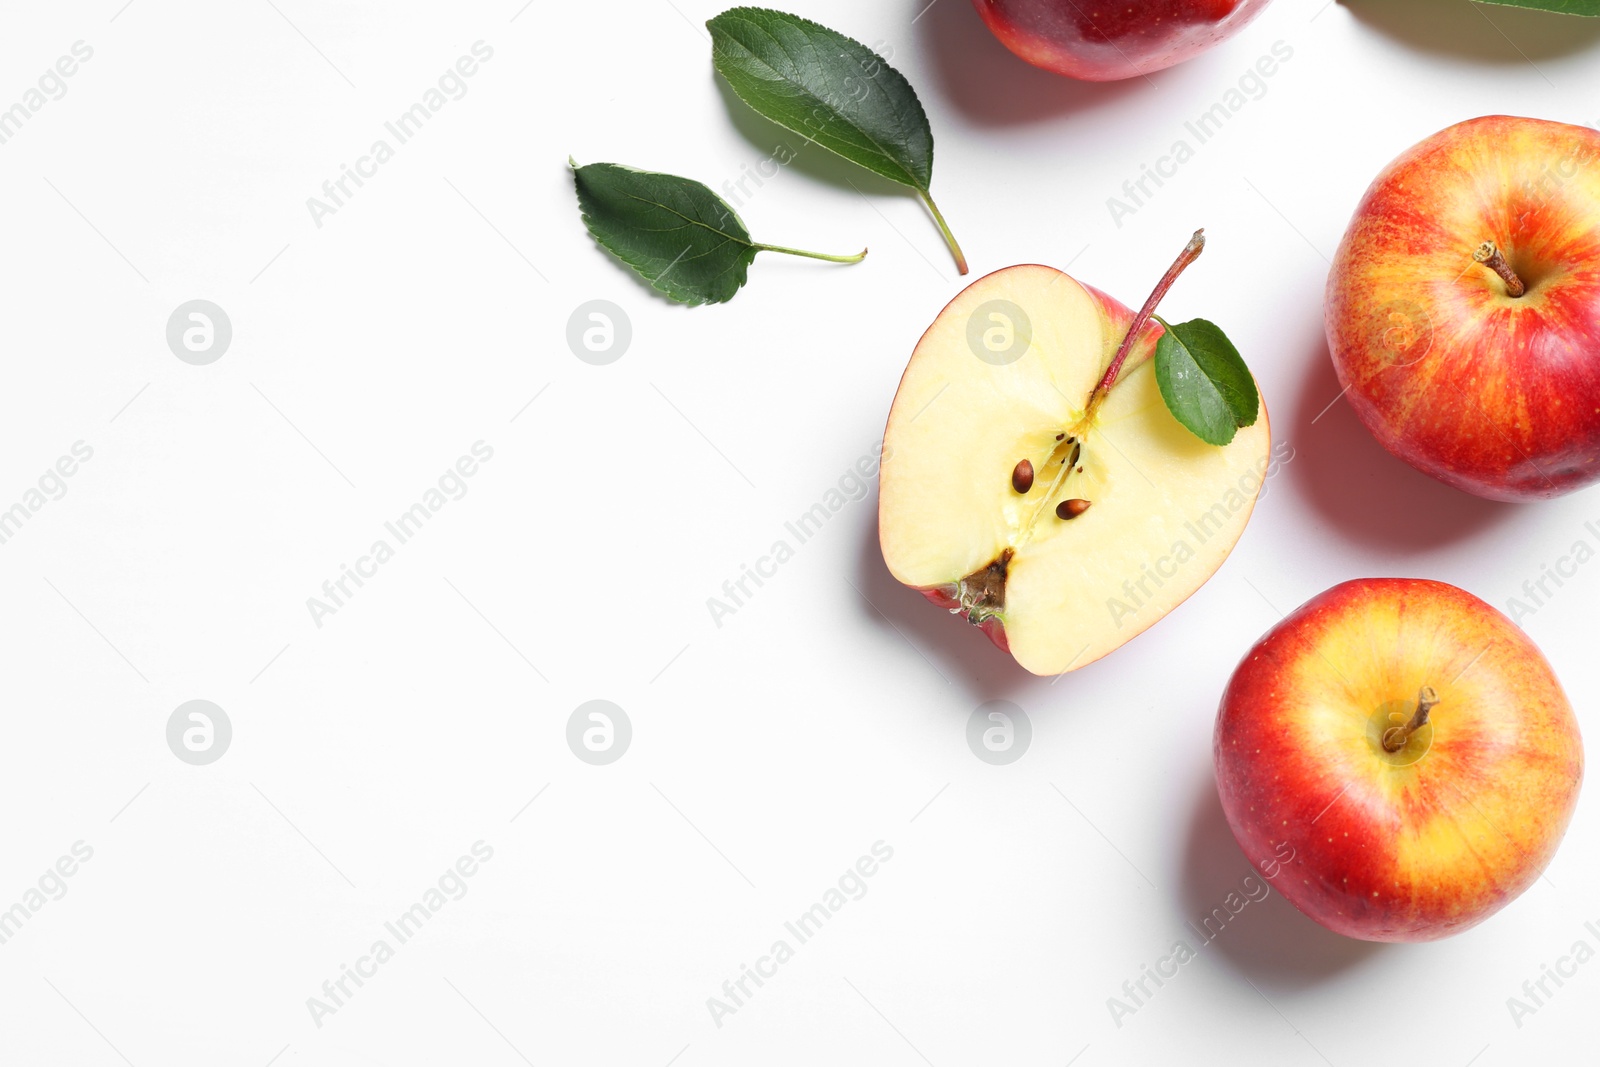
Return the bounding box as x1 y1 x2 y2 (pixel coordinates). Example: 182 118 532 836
1179 774 1387 990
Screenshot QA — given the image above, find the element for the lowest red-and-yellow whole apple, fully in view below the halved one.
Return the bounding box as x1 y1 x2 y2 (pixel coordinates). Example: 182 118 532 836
1214 577 1584 941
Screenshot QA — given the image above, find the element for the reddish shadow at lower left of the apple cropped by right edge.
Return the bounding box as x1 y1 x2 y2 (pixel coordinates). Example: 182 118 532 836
1286 334 1515 552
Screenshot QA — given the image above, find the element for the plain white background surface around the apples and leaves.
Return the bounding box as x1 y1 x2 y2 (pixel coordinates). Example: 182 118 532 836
0 0 1600 1067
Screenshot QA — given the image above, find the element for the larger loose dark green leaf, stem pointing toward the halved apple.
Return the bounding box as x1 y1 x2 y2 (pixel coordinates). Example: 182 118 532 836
706 8 966 274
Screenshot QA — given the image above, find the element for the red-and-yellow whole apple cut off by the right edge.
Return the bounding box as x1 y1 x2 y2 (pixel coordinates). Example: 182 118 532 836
1326 115 1600 501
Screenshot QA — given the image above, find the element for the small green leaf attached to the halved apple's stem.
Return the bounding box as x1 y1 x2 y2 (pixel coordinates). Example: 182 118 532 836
1155 318 1261 445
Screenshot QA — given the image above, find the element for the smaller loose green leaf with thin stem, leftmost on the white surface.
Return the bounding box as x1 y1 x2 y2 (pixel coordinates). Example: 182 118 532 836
568 160 867 307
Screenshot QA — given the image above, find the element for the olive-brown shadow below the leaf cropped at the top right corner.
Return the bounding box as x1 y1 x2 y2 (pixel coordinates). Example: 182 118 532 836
1341 0 1600 66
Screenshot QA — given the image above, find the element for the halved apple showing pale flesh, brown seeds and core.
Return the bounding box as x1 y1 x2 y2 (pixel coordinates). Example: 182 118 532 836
878 264 1272 675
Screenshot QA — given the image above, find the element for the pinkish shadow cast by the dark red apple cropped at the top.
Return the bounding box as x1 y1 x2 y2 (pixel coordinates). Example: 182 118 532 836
910 0 1150 127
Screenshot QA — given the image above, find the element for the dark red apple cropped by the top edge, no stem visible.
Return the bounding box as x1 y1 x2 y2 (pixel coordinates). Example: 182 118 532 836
973 0 1269 82
